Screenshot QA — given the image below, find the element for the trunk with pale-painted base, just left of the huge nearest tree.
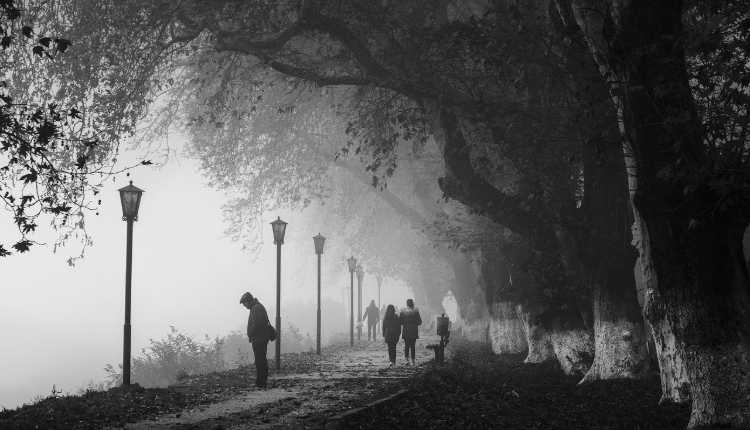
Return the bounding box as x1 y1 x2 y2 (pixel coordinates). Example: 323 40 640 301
579 122 649 383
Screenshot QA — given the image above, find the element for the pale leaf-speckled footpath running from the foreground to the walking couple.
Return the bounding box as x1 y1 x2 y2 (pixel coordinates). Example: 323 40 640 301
119 337 436 430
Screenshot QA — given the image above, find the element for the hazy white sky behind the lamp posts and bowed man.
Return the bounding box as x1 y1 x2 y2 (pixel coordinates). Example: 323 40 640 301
0 140 408 408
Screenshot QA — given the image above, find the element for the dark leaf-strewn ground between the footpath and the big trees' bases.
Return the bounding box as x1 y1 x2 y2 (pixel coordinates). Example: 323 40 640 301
342 342 690 430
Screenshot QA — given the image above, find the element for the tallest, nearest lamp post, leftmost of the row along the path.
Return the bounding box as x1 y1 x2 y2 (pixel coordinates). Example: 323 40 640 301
118 181 143 386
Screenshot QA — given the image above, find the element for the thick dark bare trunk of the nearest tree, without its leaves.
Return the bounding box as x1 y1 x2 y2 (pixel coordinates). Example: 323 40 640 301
573 0 750 428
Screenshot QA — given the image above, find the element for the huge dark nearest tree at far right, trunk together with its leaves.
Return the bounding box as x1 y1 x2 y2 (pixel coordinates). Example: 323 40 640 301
558 0 750 427
